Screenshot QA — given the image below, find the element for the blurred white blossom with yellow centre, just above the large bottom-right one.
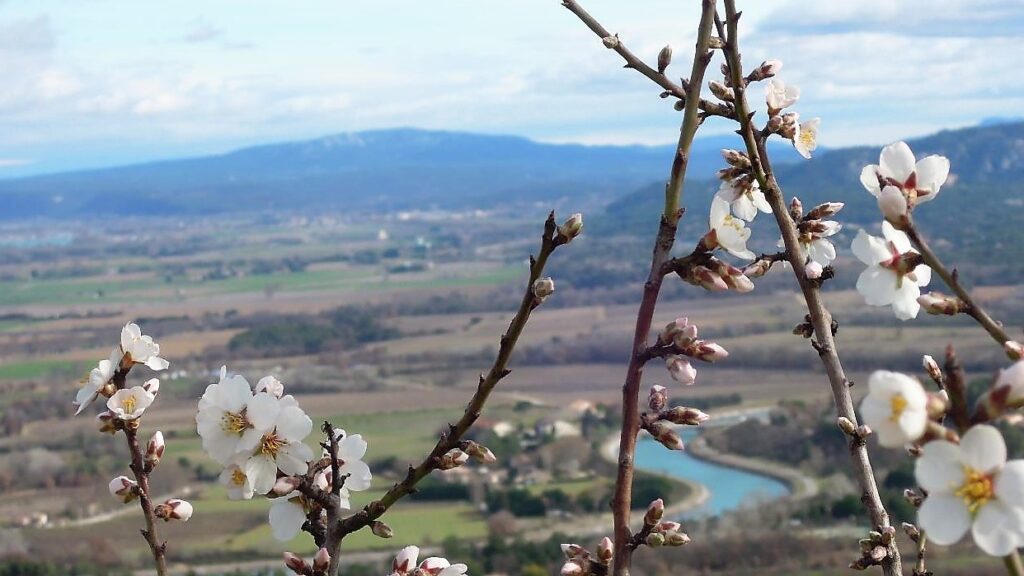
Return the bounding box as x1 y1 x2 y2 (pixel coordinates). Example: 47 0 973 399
860 370 928 448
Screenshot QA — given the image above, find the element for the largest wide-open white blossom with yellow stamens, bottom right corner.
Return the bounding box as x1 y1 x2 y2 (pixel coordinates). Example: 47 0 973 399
914 424 1024 557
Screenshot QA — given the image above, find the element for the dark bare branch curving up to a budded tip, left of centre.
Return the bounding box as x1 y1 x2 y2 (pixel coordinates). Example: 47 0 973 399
328 212 567 541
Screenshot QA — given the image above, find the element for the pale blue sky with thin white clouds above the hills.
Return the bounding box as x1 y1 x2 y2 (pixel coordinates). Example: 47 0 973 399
0 0 1024 177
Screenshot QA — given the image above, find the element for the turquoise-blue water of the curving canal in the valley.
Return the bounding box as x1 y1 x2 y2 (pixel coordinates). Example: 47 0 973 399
636 429 790 518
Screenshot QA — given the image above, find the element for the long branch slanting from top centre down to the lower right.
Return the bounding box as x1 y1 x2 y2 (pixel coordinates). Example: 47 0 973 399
716 0 903 576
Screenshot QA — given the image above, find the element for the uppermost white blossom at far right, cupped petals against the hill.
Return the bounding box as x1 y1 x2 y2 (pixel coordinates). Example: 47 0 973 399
860 142 949 208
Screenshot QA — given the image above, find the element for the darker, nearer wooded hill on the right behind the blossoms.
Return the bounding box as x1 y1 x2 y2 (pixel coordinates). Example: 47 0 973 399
590 122 1024 276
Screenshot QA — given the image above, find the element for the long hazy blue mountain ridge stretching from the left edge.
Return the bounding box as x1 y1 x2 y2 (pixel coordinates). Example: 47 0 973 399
0 129 796 218
